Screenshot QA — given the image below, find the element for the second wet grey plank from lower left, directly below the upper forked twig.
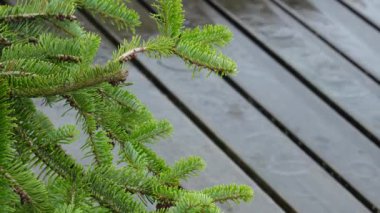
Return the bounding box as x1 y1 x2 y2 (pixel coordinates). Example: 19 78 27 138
87 1 367 212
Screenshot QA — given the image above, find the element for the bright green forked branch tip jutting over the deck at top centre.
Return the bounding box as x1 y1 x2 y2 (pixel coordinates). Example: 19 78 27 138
152 0 237 76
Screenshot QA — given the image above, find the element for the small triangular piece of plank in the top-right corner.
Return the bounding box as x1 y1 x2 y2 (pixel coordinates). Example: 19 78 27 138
338 0 380 30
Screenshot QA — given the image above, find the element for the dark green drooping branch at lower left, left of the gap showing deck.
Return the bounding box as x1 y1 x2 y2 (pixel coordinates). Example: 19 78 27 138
12 99 83 180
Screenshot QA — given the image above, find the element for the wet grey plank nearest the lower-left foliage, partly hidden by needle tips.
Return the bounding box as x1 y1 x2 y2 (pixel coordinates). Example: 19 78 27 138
74 13 282 212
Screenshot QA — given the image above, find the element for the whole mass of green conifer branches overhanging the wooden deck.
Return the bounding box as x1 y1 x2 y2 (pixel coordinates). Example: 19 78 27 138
0 0 253 213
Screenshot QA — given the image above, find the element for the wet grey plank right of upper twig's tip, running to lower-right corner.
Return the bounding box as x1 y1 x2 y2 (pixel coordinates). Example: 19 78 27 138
180 0 380 210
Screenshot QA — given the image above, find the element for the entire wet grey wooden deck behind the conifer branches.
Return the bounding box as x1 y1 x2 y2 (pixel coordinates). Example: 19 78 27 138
60 0 380 213
